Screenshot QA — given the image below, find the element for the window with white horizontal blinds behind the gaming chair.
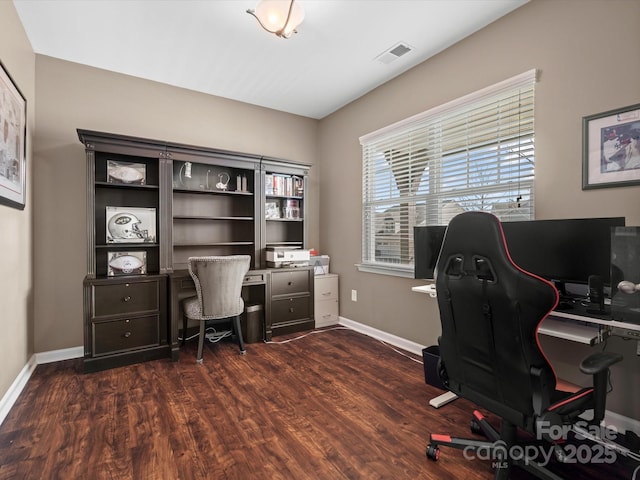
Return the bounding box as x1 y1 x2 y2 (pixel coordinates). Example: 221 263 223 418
359 70 536 277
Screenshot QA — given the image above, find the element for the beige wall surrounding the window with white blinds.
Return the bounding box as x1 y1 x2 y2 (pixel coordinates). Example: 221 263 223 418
319 0 640 419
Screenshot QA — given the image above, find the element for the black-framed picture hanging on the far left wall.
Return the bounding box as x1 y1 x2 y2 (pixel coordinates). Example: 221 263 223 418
0 62 27 210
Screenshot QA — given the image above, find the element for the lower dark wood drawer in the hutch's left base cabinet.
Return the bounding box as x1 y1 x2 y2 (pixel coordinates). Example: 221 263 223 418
92 315 160 356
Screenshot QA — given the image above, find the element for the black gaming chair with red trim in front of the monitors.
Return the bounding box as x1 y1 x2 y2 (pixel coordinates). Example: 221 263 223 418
427 212 622 479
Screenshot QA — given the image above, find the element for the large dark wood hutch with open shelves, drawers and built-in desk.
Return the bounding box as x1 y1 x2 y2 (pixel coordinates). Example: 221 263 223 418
78 129 315 371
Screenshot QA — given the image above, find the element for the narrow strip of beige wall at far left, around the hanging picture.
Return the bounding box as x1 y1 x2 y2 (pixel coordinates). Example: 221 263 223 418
0 2 35 404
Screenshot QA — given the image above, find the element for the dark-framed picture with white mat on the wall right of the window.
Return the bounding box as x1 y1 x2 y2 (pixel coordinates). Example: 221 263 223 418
582 104 640 190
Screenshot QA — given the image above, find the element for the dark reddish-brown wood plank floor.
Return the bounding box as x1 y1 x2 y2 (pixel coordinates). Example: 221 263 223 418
0 330 632 480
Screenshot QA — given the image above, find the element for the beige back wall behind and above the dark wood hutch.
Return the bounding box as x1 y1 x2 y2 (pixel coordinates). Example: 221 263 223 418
33 55 318 352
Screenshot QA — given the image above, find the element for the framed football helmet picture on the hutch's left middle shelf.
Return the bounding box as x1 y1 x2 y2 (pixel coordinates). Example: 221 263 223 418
106 207 156 243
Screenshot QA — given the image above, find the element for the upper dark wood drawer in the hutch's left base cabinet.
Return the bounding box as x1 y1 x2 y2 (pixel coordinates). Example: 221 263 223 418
93 281 160 317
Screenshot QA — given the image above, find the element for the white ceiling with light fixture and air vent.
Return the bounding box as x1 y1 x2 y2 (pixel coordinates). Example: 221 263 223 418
14 0 528 119
